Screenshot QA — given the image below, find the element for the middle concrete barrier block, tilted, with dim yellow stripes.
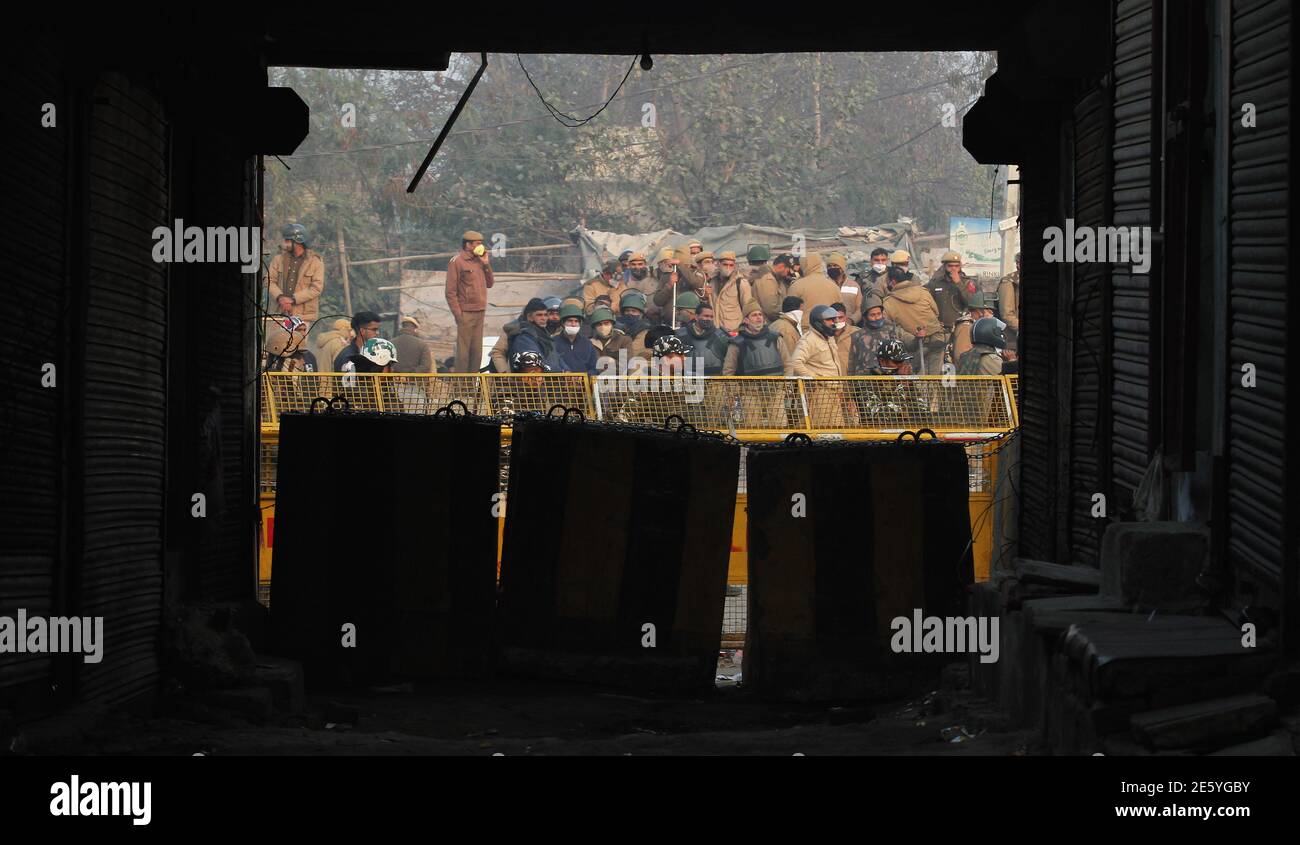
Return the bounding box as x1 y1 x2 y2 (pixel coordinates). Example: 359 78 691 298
499 415 740 692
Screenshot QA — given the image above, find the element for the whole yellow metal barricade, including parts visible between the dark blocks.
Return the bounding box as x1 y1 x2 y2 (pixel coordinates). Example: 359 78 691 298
259 373 1019 634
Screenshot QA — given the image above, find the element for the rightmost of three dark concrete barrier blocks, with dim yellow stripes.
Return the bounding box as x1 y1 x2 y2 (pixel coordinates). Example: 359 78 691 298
744 441 972 699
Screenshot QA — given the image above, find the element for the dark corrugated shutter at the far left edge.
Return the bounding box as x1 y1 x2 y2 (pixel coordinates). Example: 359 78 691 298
0 49 65 709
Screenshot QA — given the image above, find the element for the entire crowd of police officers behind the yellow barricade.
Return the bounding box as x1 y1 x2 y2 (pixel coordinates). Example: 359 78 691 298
264 224 1021 378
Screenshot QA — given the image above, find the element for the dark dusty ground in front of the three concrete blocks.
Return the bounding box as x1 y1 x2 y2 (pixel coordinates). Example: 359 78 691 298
12 654 1039 755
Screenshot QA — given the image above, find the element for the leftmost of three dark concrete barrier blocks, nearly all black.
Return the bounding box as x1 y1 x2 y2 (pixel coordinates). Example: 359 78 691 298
272 412 501 685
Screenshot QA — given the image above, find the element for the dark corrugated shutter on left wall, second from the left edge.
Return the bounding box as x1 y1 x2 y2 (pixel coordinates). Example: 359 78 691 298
81 74 168 703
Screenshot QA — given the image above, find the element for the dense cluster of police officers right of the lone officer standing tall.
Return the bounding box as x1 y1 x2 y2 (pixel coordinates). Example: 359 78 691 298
483 233 1019 378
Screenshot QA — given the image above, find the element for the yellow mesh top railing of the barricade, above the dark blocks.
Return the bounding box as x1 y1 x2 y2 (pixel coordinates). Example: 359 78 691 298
261 373 1017 441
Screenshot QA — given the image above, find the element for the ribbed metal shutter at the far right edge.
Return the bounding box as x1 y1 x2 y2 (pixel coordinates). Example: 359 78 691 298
1226 0 1295 607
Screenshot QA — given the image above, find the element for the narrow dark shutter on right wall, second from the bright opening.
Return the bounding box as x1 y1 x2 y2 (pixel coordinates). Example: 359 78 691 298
1069 88 1110 567
